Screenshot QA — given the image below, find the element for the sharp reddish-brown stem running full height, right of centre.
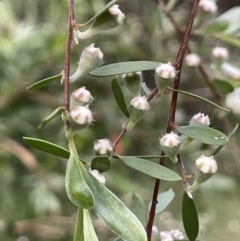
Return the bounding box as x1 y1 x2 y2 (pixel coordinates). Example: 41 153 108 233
146 0 200 241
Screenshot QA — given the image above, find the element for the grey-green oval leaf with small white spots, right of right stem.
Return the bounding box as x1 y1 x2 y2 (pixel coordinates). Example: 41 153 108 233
176 125 229 146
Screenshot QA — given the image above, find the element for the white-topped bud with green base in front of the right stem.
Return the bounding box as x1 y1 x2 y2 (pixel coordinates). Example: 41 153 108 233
160 132 180 163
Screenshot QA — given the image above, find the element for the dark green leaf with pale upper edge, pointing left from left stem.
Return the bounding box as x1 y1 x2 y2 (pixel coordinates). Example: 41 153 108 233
23 137 70 159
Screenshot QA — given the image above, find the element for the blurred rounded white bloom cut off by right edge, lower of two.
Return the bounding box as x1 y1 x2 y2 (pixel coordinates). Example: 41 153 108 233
225 87 240 115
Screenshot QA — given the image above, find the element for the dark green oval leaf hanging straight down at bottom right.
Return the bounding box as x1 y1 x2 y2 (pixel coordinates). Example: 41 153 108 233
182 192 199 241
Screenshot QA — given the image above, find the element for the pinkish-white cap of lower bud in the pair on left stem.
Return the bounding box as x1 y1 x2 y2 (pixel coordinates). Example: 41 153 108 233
70 106 93 125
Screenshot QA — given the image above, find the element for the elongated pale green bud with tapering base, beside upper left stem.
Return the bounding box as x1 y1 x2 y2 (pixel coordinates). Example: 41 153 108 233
70 44 103 82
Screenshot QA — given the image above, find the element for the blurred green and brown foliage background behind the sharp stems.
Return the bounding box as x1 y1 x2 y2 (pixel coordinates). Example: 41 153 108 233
0 0 240 241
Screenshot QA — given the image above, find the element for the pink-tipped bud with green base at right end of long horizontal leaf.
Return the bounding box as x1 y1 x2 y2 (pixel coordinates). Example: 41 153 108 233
155 62 176 96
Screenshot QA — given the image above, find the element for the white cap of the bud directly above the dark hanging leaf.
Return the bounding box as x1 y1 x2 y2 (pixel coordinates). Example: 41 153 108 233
196 155 217 174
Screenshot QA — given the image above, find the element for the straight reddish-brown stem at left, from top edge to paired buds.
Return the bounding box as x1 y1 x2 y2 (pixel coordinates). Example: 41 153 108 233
64 0 74 130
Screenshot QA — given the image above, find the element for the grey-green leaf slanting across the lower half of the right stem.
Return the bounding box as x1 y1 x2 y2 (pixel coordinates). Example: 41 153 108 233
119 156 182 181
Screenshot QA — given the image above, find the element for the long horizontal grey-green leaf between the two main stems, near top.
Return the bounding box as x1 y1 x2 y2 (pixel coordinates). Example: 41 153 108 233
89 61 159 77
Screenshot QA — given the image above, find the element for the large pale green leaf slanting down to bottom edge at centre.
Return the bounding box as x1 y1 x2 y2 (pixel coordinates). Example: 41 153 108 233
81 167 147 241
